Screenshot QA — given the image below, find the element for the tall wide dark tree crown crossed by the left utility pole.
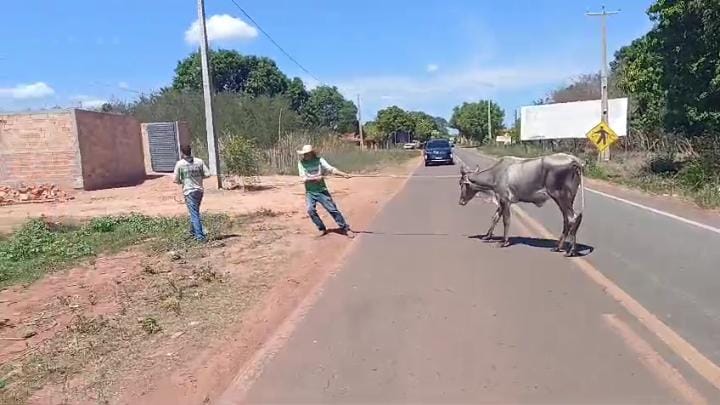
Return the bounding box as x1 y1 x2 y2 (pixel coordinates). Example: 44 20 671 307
172 49 290 96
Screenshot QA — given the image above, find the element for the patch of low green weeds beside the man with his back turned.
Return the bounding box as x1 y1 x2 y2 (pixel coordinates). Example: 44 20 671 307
0 214 231 289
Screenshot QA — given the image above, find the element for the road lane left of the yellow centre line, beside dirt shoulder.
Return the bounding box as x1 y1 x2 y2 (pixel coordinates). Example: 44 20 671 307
246 152 720 404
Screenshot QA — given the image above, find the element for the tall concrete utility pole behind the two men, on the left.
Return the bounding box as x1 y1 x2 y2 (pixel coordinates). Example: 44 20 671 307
198 0 222 189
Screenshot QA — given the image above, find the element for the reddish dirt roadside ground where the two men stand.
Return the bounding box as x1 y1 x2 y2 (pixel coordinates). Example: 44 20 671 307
0 156 418 404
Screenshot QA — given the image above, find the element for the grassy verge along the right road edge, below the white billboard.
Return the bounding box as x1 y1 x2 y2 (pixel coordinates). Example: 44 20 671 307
478 144 720 208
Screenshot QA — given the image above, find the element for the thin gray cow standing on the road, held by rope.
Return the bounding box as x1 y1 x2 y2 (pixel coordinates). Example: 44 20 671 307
460 153 585 256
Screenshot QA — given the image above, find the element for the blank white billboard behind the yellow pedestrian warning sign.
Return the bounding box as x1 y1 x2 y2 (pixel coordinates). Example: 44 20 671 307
520 98 628 141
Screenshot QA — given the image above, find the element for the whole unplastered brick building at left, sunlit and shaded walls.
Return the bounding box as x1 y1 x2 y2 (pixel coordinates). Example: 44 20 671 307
0 109 146 190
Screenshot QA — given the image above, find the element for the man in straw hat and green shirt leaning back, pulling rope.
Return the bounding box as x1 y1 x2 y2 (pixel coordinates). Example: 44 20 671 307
297 145 353 238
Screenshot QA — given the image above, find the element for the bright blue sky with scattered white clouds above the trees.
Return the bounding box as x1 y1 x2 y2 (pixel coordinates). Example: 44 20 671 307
0 0 651 120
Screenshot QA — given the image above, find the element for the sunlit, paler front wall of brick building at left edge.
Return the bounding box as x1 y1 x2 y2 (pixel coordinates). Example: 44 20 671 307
0 111 83 189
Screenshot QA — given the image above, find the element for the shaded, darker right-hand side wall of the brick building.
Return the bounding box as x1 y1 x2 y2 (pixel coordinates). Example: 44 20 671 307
74 110 146 190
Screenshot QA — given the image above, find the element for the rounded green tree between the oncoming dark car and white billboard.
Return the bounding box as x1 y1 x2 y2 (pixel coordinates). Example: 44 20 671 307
450 100 505 142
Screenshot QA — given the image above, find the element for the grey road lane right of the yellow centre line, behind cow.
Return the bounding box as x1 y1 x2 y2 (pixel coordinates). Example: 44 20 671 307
457 149 720 364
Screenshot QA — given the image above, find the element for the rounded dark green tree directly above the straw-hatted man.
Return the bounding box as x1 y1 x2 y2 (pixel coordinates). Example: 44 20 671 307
302 86 357 133
